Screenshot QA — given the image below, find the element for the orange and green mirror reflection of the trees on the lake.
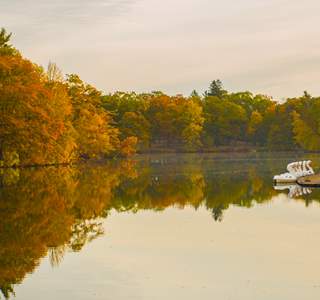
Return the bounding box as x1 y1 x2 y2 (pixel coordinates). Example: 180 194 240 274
0 157 320 298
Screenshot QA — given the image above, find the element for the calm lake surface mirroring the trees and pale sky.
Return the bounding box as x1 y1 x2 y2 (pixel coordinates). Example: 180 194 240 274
0 154 320 300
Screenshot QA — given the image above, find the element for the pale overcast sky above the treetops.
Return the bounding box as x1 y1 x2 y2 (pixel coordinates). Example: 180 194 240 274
0 0 320 98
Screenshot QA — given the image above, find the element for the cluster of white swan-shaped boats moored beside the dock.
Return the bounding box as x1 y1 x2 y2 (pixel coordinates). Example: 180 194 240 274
273 160 314 184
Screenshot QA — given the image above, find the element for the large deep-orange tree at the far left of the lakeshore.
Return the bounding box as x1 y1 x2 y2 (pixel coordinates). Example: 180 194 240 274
0 31 73 166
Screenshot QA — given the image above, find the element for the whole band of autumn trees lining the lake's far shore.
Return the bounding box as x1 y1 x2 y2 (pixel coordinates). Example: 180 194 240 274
0 29 320 166
